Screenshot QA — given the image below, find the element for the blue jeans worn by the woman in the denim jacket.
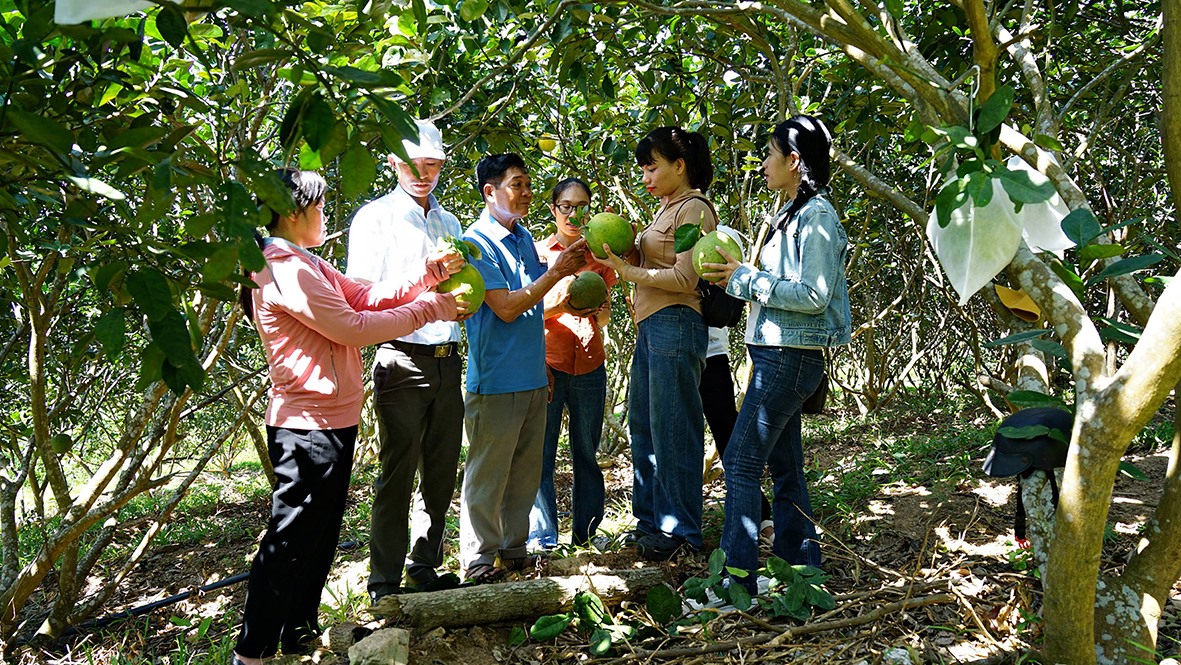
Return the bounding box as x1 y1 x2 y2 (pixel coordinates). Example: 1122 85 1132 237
722 345 824 592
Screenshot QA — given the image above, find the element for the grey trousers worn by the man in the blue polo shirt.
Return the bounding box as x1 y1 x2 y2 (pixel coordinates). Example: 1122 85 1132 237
459 387 547 571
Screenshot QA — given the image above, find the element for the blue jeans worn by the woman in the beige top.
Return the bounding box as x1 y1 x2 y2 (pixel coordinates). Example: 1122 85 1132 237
627 305 706 549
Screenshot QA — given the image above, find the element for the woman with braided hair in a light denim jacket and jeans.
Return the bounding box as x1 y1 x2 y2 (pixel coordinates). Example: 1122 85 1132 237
707 116 852 593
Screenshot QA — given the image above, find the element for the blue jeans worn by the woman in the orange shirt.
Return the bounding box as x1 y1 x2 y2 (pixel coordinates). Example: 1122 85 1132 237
529 366 607 547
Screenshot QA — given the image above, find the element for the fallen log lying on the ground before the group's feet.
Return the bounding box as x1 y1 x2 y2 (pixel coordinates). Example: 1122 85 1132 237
368 568 665 630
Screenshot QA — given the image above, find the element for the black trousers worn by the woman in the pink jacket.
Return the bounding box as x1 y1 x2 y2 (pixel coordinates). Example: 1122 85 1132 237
235 425 357 658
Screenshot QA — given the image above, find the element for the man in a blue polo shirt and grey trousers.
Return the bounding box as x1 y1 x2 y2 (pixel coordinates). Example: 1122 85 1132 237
459 154 586 582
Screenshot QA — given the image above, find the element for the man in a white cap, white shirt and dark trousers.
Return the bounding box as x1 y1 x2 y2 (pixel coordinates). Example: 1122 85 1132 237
347 120 463 601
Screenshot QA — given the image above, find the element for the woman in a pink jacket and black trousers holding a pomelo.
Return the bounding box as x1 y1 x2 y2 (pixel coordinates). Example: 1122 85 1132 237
233 169 468 665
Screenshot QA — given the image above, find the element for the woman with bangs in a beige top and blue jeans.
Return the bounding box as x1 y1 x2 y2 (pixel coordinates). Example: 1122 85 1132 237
601 128 718 560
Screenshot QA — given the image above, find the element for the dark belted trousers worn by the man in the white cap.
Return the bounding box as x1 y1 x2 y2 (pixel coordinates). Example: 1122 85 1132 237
368 346 463 595
